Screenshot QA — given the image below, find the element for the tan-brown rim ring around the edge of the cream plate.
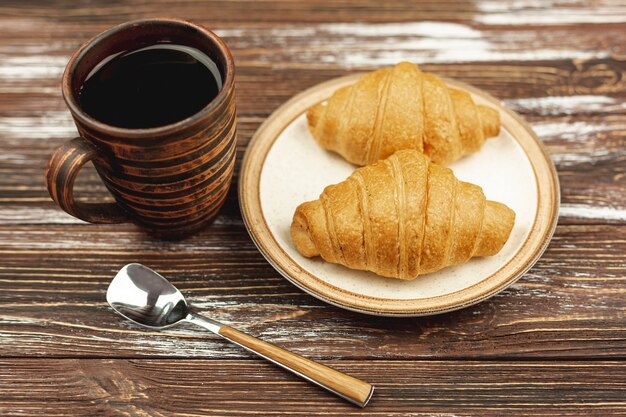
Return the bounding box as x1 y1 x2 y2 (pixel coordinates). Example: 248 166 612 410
238 73 560 317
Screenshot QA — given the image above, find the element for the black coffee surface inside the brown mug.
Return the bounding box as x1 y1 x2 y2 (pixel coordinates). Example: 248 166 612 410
79 43 222 128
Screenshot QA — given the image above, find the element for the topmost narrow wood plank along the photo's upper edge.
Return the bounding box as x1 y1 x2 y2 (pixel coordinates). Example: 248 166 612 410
0 0 626 25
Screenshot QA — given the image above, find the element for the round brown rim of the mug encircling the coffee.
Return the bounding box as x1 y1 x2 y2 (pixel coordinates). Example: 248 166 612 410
61 18 235 140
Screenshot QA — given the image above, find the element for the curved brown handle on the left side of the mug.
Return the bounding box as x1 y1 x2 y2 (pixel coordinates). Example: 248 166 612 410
46 136 128 224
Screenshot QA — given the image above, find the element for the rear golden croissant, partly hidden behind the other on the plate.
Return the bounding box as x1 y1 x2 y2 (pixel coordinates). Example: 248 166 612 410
307 62 500 165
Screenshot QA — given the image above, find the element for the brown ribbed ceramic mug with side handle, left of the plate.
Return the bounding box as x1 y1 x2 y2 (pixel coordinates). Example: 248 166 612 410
46 19 236 236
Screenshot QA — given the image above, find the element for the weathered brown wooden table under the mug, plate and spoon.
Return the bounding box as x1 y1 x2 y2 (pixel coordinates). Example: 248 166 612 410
0 0 626 416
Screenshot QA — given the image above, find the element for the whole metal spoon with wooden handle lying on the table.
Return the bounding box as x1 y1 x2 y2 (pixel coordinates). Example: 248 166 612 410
107 263 374 407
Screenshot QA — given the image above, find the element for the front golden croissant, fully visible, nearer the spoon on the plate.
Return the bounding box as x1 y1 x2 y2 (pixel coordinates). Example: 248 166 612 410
291 150 515 280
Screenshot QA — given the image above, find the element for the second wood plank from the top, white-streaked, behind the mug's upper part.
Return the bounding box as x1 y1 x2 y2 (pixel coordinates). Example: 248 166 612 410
0 19 626 99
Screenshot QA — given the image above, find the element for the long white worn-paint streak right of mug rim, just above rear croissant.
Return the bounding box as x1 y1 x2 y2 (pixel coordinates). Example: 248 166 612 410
217 22 608 68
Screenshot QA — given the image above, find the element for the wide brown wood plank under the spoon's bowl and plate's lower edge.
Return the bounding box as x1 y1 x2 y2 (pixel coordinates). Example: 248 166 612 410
0 224 626 359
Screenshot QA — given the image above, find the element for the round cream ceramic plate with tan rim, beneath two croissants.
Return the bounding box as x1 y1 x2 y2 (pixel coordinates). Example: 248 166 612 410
239 75 559 316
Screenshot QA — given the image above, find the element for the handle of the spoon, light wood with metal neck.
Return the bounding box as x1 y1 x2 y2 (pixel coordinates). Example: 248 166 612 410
189 314 374 407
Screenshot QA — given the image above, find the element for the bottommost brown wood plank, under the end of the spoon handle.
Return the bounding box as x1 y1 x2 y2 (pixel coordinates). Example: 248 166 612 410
0 359 626 417
